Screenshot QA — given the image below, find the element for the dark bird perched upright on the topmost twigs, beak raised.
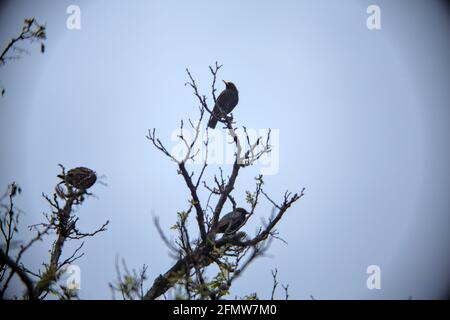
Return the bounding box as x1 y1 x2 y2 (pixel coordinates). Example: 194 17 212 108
208 80 239 129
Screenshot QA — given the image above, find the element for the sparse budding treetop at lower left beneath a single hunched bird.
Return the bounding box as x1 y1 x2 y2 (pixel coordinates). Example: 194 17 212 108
0 165 109 299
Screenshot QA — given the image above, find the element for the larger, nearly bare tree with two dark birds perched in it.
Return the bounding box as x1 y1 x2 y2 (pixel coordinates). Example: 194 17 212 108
142 62 304 300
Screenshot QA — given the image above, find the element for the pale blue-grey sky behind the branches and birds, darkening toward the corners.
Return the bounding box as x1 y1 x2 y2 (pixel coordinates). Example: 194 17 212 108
0 0 450 299
